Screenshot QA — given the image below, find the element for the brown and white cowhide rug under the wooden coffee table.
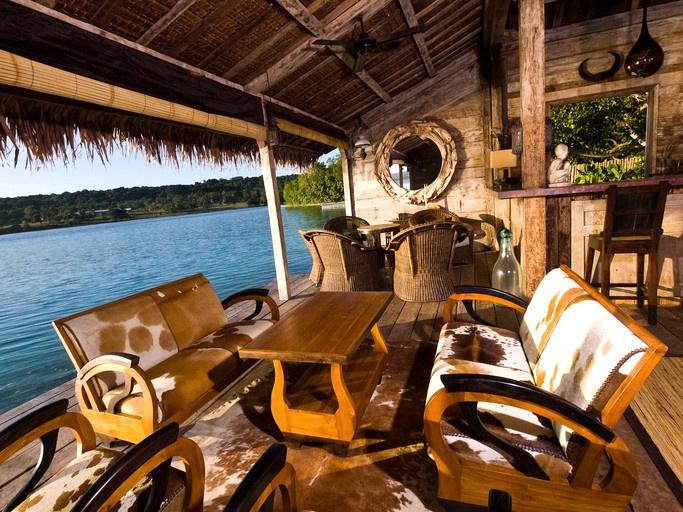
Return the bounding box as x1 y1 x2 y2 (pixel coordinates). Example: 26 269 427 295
183 341 442 512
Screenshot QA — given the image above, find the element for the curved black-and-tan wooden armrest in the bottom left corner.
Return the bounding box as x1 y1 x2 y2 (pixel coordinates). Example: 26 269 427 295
0 399 97 510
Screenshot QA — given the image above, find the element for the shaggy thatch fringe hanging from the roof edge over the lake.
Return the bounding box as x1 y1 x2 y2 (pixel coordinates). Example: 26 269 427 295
0 94 320 169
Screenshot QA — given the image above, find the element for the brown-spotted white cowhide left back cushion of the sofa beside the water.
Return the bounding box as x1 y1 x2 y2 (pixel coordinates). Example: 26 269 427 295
64 295 178 389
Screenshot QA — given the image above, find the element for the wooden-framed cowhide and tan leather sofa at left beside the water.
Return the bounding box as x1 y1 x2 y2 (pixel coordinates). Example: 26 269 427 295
53 274 279 443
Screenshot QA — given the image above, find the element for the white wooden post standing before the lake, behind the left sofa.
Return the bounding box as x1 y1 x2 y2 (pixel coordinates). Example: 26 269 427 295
257 140 289 300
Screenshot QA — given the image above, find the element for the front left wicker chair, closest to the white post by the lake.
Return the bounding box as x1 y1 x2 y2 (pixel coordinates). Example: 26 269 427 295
304 230 386 292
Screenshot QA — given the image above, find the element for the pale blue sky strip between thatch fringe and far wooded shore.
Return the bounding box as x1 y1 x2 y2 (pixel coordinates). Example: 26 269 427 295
0 151 310 197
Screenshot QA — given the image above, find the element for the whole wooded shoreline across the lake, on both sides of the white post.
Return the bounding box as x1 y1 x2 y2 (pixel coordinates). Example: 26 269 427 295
0 157 344 234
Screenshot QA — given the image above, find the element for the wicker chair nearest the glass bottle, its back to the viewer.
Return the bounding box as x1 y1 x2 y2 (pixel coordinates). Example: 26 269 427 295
389 221 467 302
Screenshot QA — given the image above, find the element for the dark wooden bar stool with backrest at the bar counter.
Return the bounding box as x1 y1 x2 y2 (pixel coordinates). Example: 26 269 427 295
586 181 671 324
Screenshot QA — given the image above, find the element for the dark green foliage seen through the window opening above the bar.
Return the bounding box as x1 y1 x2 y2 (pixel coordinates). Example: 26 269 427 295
551 94 647 164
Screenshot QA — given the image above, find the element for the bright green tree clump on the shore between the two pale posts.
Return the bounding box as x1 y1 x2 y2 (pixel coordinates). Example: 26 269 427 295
283 156 344 205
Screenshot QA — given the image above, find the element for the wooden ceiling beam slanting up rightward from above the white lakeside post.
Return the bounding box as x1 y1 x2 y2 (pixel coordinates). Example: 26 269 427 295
245 0 393 93
